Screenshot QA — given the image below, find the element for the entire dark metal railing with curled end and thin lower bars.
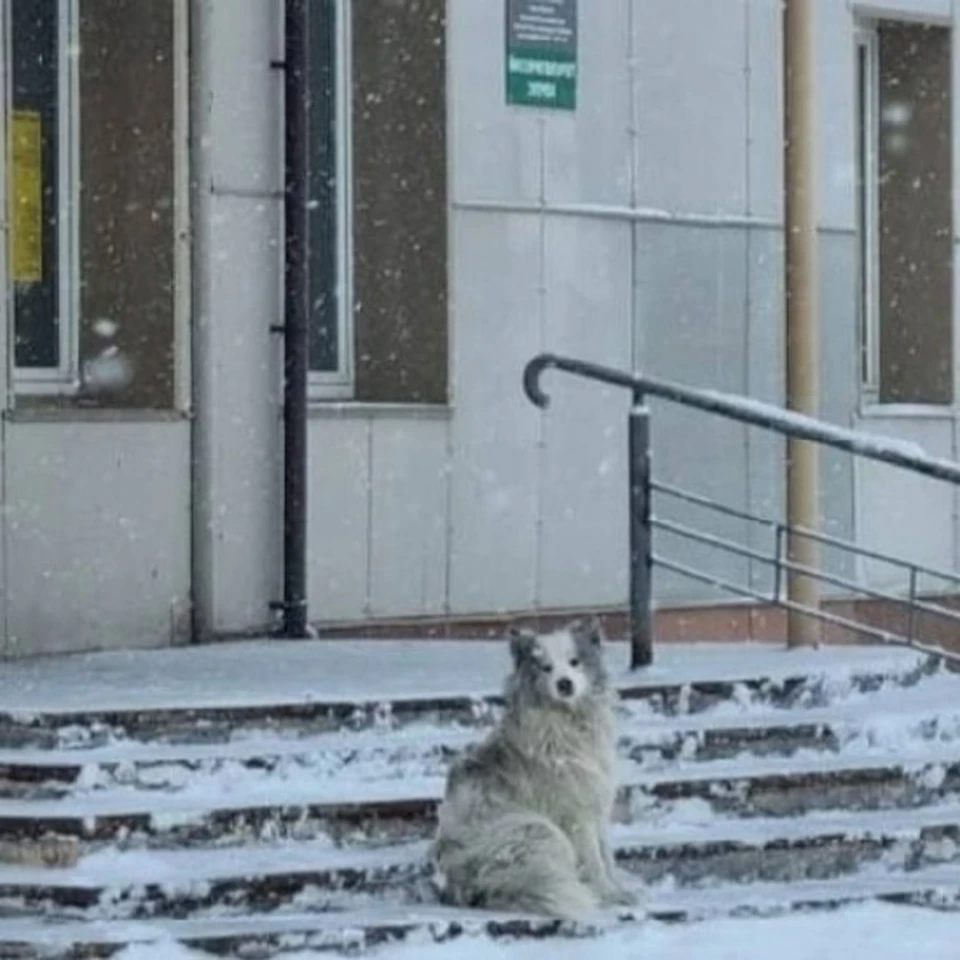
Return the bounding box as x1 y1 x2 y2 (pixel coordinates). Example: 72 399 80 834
523 353 960 667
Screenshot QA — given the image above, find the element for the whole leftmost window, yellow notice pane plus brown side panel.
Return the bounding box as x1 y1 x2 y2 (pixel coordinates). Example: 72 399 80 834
5 0 178 409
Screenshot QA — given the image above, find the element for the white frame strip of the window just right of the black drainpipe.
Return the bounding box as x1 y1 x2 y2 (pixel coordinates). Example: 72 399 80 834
308 0 354 401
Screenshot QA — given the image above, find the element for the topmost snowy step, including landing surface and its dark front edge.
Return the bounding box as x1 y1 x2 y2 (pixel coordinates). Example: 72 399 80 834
0 641 938 749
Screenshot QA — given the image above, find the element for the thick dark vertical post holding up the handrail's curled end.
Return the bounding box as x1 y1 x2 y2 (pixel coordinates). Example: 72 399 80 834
629 391 653 669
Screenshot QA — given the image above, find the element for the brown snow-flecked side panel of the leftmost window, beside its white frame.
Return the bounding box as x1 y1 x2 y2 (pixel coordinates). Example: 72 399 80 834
78 0 177 409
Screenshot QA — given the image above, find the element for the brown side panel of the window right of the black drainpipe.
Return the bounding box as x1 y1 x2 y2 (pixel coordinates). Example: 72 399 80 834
350 0 449 404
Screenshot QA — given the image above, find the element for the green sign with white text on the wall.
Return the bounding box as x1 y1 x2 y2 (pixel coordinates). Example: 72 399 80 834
506 0 577 110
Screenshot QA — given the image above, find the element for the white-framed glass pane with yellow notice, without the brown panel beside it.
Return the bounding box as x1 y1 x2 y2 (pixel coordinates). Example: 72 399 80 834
8 0 77 392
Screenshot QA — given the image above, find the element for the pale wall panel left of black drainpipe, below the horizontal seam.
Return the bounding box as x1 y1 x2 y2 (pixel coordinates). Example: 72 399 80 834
195 196 283 632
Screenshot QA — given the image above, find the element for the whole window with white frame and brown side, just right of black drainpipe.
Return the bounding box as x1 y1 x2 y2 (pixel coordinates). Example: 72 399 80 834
309 0 448 404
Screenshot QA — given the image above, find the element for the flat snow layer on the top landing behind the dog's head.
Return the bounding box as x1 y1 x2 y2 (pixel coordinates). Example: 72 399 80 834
0 640 920 716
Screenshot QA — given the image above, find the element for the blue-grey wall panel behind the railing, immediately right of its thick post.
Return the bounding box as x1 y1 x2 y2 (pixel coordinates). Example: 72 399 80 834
636 225 748 603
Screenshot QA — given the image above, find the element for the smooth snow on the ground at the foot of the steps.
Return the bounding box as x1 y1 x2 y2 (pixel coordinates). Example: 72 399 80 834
109 904 960 960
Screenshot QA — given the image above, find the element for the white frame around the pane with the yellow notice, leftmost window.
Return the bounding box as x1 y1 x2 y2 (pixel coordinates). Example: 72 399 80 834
4 0 80 394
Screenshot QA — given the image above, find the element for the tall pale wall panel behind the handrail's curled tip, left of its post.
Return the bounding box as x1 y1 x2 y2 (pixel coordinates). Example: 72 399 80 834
538 219 632 607
